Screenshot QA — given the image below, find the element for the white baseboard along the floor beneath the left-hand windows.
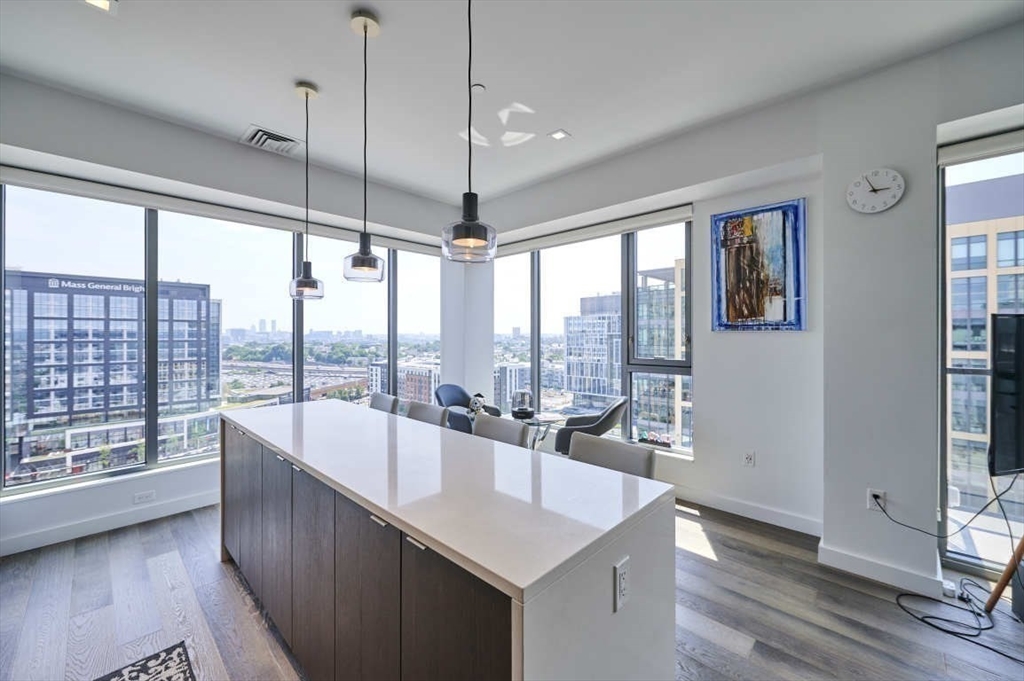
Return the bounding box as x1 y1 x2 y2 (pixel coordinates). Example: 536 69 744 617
0 490 220 556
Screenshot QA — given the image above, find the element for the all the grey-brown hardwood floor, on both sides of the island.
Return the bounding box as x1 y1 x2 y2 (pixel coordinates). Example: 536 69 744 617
0 504 1024 681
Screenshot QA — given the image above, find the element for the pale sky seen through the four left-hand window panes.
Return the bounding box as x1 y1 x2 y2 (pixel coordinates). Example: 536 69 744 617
4 185 440 334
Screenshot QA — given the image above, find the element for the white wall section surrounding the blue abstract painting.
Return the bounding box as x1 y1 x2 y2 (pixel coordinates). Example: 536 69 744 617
658 179 824 535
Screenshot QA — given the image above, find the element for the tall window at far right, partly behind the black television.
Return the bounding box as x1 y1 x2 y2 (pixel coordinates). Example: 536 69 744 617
943 142 1024 567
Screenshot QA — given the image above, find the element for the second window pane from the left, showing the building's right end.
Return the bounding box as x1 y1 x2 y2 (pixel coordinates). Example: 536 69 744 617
157 211 295 460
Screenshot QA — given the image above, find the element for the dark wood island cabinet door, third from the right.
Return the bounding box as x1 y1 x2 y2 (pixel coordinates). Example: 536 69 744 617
292 467 336 681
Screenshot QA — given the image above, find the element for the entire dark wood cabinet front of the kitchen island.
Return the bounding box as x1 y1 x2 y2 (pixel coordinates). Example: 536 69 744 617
221 424 512 681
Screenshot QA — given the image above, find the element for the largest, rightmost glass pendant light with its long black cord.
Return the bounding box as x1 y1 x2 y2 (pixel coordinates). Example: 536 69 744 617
441 0 498 262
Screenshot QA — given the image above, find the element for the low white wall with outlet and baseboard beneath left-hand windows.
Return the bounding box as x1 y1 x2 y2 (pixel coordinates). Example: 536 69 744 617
0 459 220 556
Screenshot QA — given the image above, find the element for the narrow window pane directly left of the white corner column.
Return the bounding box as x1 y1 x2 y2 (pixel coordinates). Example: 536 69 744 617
387 251 438 403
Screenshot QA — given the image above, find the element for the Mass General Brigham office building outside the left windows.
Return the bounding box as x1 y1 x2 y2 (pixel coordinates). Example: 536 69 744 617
4 270 220 466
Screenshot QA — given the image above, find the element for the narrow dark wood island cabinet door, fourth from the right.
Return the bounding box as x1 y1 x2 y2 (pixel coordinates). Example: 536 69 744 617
260 448 292 645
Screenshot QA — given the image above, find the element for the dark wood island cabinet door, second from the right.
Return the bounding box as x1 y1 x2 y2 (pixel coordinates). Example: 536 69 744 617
335 495 401 681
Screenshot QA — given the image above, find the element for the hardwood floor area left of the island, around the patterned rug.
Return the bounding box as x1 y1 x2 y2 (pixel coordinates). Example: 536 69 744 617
0 506 299 681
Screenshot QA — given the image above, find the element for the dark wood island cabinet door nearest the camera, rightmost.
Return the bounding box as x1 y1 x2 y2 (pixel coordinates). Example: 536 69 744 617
401 536 512 681
